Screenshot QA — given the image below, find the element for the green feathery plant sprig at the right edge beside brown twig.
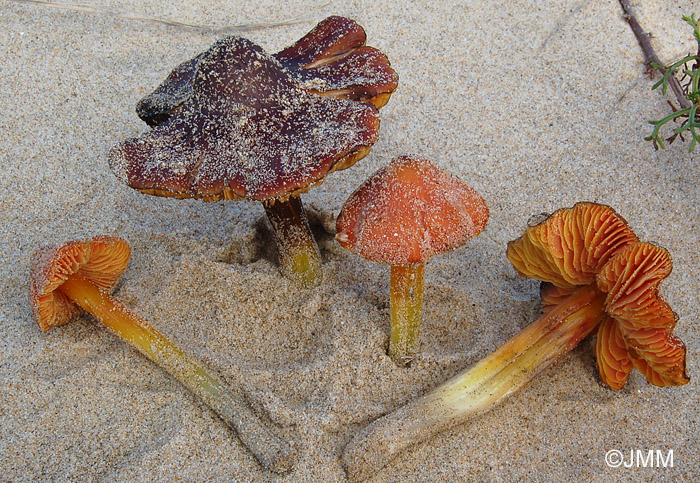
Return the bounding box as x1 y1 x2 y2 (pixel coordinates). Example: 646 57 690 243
644 14 700 152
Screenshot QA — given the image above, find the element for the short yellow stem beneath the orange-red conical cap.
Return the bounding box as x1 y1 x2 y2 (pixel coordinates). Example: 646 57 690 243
389 263 425 366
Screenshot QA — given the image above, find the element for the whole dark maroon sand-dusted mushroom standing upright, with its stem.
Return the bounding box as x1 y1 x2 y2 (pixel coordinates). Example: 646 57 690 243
109 17 398 287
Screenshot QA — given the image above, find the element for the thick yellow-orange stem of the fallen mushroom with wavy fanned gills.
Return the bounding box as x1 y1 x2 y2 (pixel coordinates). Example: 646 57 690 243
343 285 605 481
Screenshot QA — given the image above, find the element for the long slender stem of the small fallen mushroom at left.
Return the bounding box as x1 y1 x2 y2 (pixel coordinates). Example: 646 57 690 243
58 273 294 473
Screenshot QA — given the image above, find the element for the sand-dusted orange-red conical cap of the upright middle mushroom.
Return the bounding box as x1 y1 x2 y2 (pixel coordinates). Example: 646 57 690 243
336 156 489 265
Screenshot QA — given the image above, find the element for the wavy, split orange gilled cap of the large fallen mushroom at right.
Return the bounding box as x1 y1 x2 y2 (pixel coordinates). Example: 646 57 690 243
506 203 689 389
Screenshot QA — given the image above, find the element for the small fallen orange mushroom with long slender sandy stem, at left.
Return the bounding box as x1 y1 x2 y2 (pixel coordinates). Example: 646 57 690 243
29 236 295 473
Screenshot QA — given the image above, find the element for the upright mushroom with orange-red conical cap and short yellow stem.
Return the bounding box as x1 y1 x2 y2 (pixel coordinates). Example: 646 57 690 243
336 156 489 366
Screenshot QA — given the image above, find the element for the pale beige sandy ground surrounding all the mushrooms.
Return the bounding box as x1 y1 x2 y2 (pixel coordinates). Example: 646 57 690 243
0 0 700 482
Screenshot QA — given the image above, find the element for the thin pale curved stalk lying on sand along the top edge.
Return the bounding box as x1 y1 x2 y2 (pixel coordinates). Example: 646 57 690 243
10 0 333 34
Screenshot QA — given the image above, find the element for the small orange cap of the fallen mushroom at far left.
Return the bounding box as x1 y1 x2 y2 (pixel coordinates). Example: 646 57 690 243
29 236 131 331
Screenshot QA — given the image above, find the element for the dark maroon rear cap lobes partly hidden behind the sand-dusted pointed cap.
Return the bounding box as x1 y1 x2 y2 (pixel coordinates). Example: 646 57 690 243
136 16 398 126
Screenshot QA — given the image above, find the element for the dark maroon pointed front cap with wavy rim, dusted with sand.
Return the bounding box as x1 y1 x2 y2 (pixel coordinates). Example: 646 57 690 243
109 37 379 201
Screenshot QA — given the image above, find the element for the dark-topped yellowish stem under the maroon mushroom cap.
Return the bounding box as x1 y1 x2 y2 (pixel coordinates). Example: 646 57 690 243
264 196 323 288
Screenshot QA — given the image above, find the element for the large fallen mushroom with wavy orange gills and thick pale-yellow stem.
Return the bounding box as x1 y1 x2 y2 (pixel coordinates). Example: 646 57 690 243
343 203 689 480
